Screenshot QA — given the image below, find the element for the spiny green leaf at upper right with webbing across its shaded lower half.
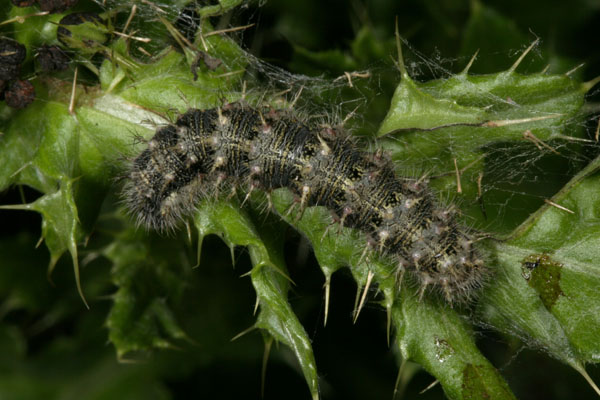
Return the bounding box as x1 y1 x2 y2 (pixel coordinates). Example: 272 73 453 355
379 45 586 234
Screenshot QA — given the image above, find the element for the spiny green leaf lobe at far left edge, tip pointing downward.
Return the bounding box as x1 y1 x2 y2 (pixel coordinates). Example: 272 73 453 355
2 102 87 306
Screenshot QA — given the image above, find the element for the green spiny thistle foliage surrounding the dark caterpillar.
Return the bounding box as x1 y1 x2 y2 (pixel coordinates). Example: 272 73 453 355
0 1 600 399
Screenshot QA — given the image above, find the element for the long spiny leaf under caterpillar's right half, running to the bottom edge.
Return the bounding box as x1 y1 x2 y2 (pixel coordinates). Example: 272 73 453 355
264 191 514 399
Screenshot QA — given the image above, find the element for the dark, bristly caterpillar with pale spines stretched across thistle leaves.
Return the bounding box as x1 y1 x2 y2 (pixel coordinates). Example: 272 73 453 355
125 103 485 304
